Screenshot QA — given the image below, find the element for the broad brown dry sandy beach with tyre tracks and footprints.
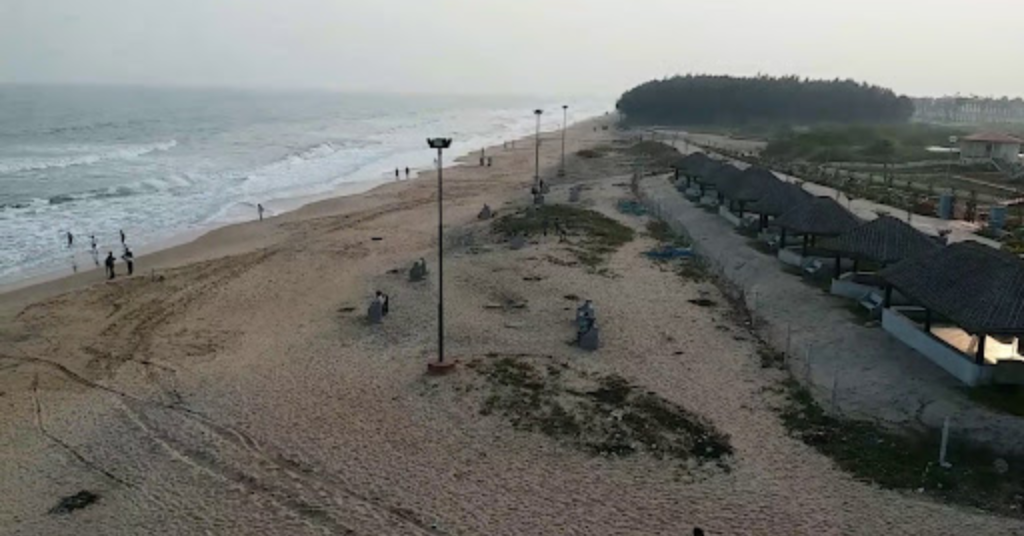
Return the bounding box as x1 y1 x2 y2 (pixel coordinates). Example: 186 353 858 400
0 119 1024 535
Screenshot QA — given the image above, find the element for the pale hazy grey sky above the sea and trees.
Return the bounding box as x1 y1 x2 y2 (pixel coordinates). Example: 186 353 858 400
0 0 1024 95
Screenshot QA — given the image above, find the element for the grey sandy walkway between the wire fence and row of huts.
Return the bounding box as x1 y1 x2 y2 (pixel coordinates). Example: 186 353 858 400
640 176 1024 453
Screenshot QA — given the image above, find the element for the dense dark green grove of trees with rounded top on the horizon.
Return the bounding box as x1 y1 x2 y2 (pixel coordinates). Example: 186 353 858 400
615 75 913 125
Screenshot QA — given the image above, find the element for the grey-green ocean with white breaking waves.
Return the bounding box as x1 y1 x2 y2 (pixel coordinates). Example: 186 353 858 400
0 86 611 284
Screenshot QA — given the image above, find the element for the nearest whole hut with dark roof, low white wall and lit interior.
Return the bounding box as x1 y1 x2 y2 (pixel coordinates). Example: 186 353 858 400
880 242 1024 385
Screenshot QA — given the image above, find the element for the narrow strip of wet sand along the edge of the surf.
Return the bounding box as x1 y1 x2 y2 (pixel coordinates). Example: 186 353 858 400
0 115 606 319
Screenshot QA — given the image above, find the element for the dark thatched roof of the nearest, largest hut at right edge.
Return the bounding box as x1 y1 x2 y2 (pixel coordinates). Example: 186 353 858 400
880 241 1024 335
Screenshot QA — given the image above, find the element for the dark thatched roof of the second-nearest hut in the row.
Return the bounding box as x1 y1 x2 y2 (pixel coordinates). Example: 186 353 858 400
820 215 942 264
